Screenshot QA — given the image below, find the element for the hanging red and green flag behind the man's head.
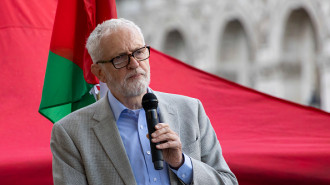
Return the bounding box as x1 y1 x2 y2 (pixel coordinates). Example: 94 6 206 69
39 0 117 123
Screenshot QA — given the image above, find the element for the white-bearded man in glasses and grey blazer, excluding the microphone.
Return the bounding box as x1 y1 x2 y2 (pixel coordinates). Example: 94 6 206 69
51 19 237 185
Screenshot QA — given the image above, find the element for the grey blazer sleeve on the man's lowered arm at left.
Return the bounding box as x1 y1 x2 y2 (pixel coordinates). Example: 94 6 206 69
50 124 88 185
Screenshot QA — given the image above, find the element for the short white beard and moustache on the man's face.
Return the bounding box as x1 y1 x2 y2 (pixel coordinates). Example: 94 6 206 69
107 68 150 97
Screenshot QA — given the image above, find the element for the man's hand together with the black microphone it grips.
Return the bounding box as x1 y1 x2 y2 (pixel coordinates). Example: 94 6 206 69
142 93 184 170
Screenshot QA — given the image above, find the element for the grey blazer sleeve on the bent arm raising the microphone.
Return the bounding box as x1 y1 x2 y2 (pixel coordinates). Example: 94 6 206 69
191 100 238 185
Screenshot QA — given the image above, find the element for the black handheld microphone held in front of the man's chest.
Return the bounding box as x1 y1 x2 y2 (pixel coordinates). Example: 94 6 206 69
142 93 164 170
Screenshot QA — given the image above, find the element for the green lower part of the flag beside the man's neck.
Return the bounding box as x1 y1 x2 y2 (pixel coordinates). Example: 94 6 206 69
39 51 95 123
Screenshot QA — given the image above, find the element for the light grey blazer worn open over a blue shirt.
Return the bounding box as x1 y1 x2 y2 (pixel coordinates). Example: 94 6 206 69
50 92 238 185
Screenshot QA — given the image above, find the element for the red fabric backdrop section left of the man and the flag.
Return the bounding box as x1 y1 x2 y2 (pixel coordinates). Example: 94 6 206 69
0 0 56 185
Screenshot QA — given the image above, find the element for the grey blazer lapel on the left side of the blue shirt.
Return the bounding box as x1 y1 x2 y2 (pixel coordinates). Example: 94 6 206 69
93 96 136 185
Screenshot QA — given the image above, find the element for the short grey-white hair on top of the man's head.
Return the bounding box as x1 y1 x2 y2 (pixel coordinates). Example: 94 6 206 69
86 18 144 63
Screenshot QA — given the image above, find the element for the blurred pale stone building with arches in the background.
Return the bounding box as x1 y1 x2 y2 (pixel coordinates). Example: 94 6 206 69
116 0 330 112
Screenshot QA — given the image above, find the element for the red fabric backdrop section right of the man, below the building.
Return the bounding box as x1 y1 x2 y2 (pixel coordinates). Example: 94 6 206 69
150 50 330 185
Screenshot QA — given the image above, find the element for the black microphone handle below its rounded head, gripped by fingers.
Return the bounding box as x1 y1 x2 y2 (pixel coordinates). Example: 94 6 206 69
146 109 164 170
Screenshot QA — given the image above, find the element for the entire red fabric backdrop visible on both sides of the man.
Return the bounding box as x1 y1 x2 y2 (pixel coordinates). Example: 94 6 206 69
0 0 330 185
